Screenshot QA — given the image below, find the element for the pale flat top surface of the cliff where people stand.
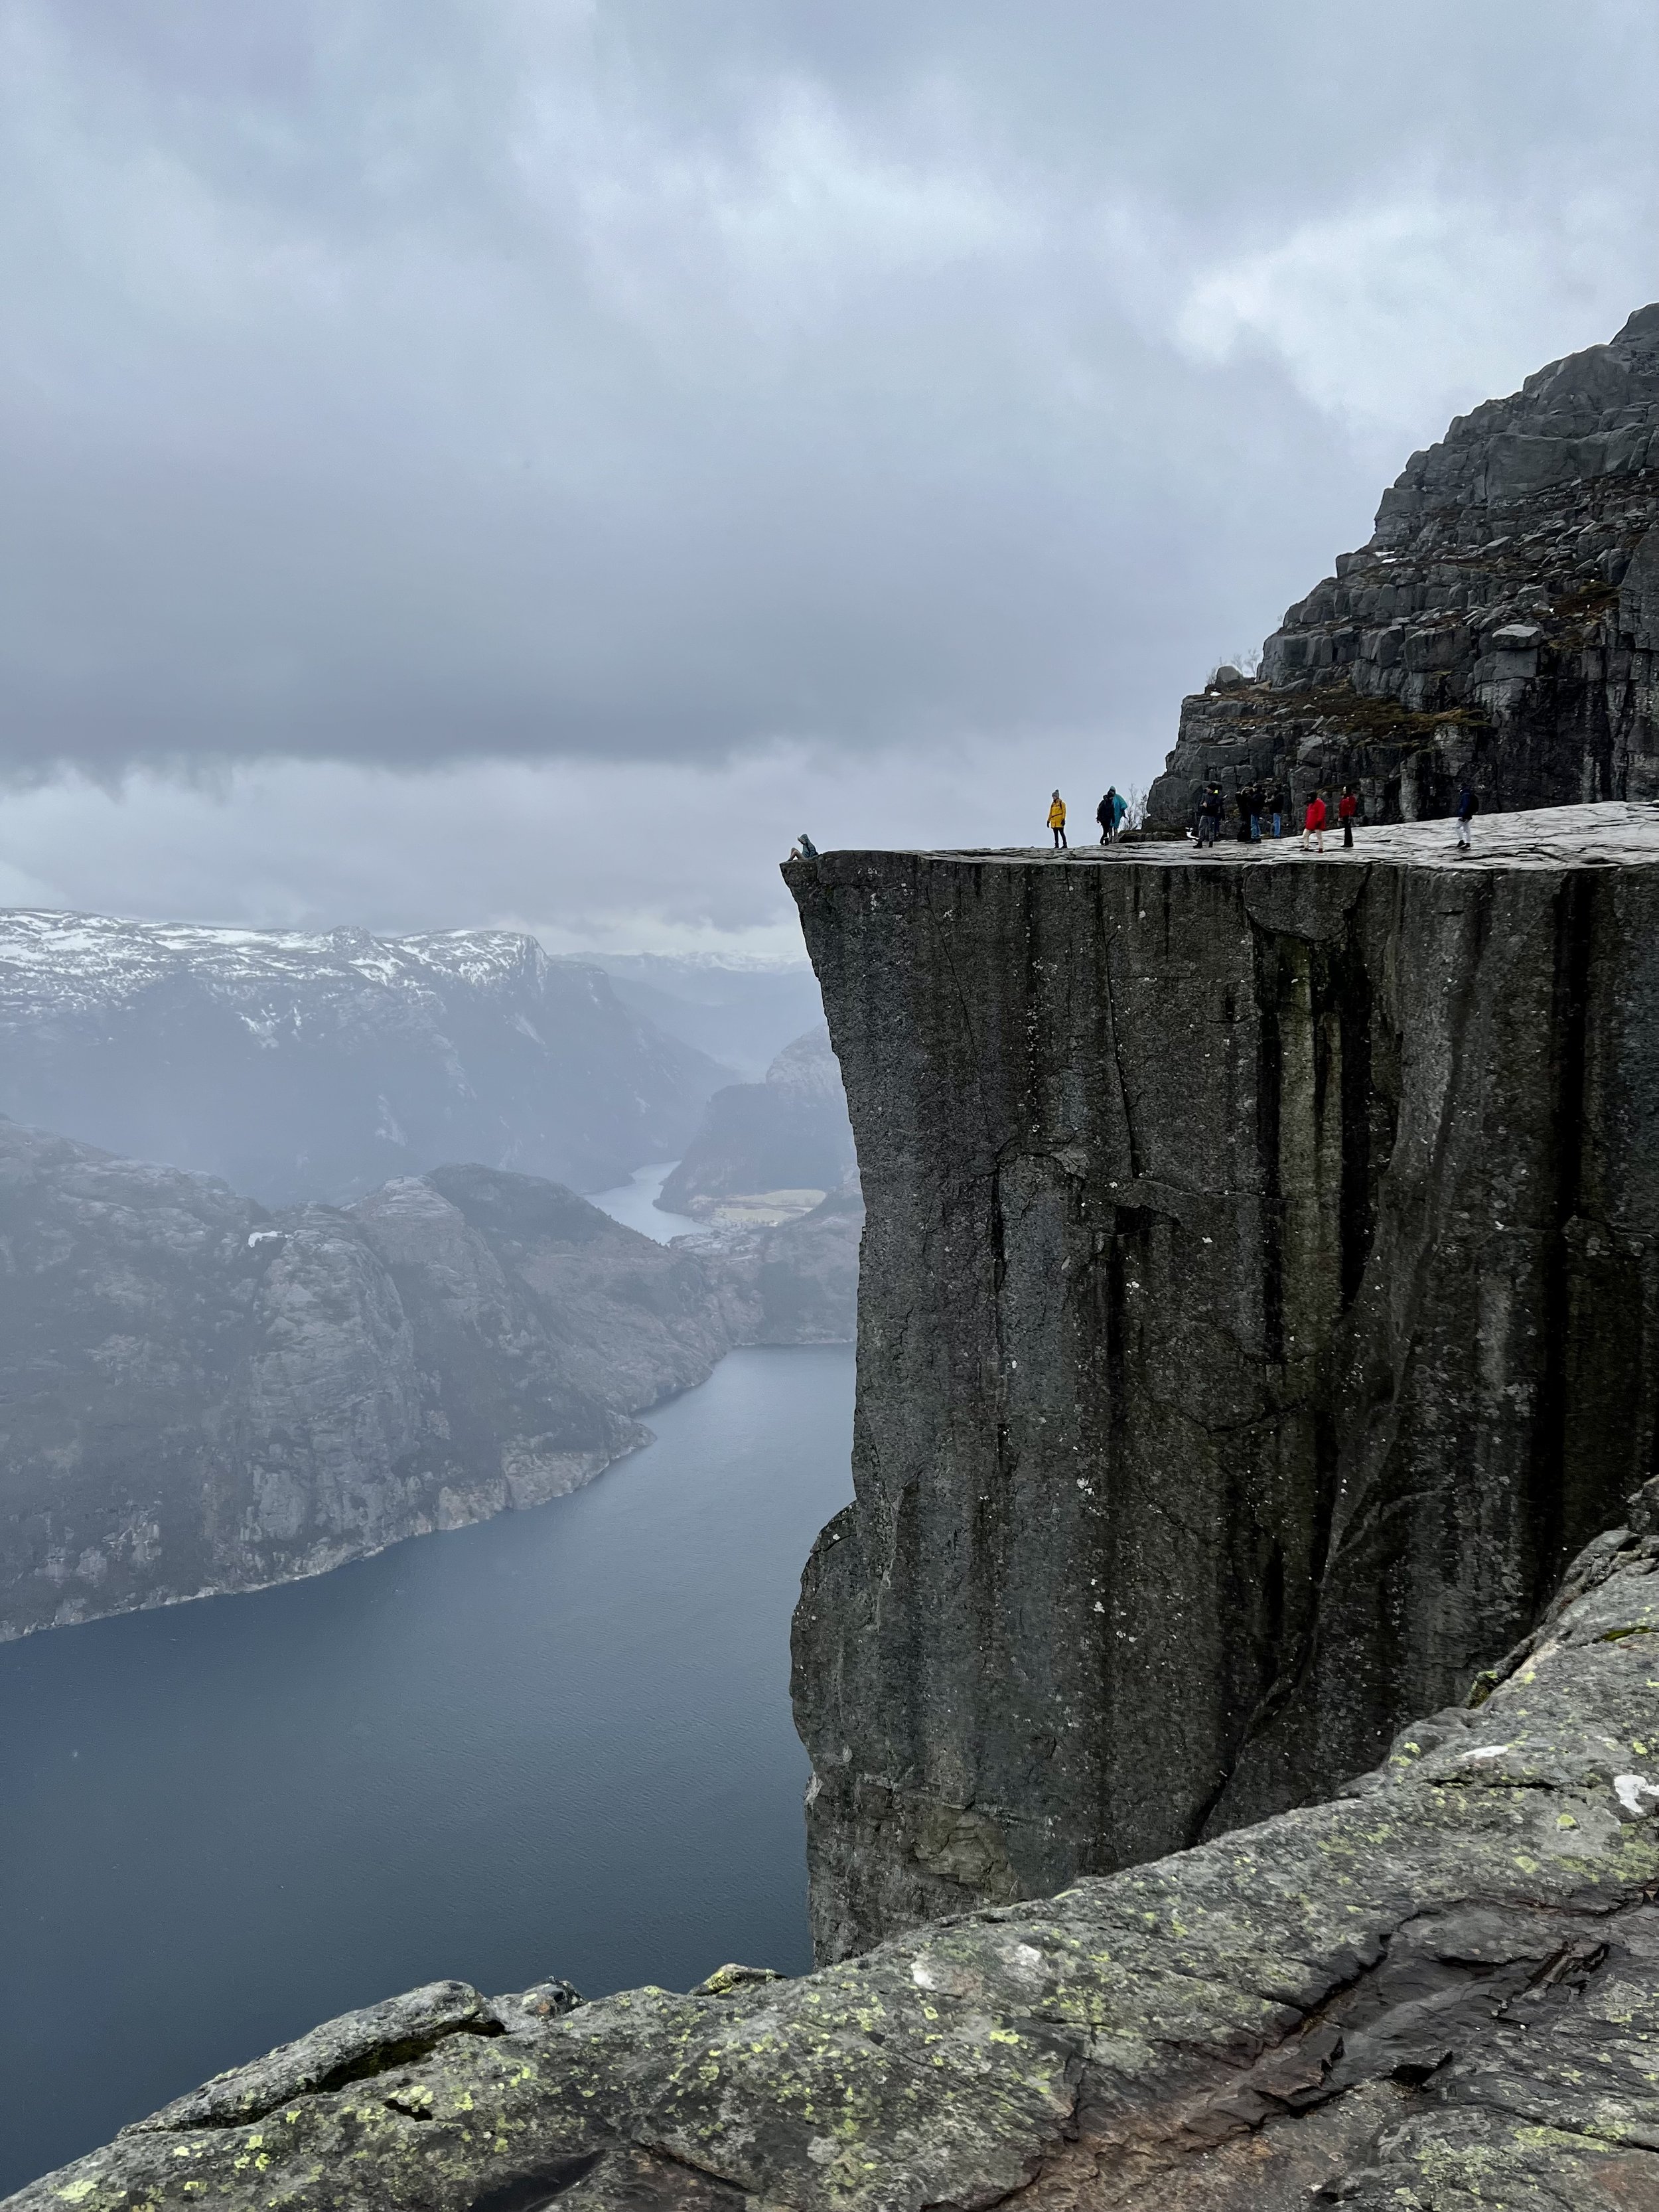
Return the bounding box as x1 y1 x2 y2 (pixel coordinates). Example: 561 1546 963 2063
785 801 1659 862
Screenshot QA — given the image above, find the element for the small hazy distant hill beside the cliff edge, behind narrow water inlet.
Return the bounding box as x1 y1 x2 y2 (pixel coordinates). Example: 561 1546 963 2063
657 1027 854 1228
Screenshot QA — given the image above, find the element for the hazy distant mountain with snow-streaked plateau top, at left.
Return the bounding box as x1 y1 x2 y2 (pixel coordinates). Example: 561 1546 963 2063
0 909 730 1203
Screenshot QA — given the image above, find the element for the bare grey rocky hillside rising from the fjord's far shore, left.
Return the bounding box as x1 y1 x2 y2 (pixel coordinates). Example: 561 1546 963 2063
0 1122 732 1635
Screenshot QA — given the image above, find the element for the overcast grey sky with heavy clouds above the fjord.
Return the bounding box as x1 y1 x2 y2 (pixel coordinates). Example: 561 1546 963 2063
0 0 1659 956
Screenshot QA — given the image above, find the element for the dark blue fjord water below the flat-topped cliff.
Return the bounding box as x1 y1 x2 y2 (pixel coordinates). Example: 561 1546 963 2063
0 1347 851 2192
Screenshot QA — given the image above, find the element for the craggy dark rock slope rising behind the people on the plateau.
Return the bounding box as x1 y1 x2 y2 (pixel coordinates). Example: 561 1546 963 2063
1148 305 1659 830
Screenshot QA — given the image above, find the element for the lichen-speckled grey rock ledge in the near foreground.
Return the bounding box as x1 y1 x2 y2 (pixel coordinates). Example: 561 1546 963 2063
7 1500 1659 2212
